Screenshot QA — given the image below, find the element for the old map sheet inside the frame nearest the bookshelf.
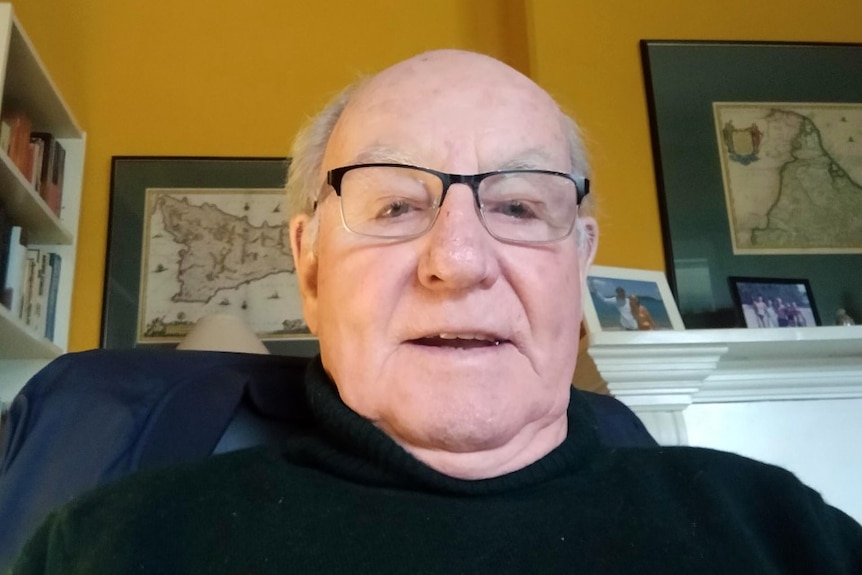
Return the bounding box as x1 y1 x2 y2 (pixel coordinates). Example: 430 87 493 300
137 188 309 343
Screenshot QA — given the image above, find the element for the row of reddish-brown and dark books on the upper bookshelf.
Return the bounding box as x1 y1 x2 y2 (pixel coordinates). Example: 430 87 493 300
0 109 66 216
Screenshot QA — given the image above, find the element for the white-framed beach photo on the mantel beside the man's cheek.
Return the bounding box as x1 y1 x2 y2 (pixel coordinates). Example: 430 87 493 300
584 266 685 333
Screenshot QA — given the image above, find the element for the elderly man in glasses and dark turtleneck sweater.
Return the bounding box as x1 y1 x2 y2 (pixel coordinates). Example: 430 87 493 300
13 51 862 574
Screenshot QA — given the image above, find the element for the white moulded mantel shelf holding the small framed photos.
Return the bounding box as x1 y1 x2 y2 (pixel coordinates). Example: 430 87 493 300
589 326 862 409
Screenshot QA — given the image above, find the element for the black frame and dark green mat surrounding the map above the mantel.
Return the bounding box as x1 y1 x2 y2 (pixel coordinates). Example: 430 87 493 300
640 40 862 329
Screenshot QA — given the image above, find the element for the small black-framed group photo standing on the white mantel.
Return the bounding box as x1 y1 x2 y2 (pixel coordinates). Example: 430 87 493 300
728 276 820 328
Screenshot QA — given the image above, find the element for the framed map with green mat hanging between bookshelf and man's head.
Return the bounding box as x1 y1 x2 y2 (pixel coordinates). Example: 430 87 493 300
101 156 313 354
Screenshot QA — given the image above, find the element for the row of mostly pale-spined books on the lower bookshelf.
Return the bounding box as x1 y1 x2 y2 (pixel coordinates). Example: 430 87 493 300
0 213 62 340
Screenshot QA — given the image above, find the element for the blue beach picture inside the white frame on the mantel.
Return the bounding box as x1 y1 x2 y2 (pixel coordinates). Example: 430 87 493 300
587 275 674 331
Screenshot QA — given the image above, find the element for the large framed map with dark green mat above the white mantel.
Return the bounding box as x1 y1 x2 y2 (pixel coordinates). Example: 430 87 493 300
641 40 862 329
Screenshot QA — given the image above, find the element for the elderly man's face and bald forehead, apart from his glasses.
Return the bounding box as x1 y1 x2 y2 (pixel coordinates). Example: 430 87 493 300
292 52 593 476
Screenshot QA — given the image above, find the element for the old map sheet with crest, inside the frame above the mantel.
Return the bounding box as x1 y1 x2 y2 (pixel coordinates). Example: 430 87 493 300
713 102 862 254
